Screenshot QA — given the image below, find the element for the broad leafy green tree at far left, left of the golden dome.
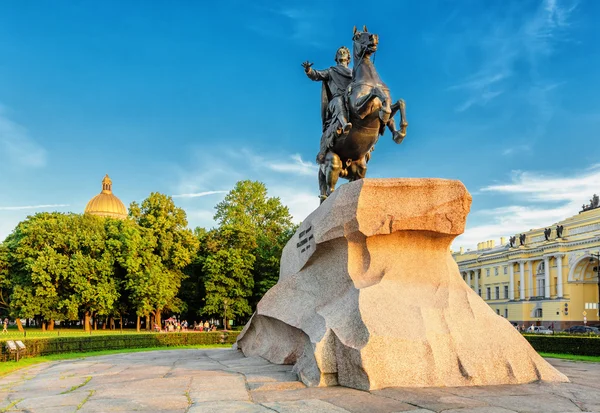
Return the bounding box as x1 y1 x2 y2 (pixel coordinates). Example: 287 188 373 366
5 213 118 330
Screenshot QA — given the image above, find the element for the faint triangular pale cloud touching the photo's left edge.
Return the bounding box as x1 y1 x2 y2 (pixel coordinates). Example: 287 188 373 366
0 105 46 168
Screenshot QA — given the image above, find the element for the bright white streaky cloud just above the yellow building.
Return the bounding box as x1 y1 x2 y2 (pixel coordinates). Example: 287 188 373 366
454 165 600 247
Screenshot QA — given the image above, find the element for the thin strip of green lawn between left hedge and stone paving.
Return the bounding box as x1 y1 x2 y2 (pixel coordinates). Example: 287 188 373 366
0 344 231 377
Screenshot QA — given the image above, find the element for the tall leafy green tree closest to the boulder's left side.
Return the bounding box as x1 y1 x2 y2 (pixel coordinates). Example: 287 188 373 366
203 180 295 318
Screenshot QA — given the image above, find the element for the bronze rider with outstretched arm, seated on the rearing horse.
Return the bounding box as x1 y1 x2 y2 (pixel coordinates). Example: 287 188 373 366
302 46 352 163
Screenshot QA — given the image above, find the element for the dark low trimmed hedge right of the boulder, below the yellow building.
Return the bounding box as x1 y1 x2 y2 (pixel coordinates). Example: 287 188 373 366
524 334 600 356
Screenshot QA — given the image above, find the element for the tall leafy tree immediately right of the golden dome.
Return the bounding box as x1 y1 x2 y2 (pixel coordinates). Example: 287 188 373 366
129 192 198 326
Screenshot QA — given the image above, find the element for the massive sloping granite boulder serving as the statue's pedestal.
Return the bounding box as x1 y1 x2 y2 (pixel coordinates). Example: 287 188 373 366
237 179 568 390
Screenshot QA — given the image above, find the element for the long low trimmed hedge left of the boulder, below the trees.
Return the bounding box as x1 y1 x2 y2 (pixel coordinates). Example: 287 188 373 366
1 331 240 361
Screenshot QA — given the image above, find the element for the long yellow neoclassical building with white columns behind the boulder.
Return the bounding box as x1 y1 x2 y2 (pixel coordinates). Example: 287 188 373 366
453 196 600 330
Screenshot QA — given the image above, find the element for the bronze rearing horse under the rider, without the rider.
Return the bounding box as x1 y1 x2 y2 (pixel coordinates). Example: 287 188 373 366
319 26 408 202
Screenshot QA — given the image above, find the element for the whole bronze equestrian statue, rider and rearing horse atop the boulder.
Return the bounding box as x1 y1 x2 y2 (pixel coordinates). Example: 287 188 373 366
302 26 408 202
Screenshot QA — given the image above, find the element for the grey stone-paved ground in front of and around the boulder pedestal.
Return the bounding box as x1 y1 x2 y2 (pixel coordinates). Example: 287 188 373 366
0 349 600 413
